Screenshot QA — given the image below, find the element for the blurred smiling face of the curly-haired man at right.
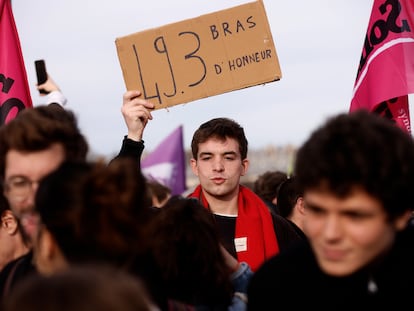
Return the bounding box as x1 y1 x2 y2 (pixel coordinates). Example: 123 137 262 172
304 188 409 276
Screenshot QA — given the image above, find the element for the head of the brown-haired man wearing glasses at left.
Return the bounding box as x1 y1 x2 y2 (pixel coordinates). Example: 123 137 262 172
0 105 88 241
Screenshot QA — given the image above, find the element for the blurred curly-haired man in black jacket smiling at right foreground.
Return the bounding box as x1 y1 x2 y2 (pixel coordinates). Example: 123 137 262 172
248 110 414 311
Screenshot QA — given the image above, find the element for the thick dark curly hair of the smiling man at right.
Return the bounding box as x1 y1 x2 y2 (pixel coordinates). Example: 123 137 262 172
295 110 414 219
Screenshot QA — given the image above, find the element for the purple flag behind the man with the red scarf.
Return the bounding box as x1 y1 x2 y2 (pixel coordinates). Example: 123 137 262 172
141 125 187 195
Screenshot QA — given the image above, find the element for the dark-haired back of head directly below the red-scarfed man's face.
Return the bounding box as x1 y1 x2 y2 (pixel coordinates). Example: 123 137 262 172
149 196 232 304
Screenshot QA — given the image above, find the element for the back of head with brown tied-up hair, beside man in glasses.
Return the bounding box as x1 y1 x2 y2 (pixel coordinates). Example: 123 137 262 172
34 158 149 274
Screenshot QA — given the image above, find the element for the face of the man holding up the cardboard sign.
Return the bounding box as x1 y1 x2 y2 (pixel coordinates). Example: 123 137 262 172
191 138 248 204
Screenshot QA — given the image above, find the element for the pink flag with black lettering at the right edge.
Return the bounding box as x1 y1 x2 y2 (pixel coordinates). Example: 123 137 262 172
350 0 414 133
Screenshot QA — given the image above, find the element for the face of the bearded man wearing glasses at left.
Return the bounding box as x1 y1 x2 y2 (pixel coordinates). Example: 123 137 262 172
4 144 65 241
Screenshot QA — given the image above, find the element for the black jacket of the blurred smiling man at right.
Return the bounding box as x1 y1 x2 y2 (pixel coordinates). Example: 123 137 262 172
248 226 414 311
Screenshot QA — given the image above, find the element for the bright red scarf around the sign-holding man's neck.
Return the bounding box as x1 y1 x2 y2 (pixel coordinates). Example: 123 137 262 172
188 185 279 271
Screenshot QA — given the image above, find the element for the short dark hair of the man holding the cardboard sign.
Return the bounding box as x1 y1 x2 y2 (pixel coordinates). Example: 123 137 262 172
191 118 248 160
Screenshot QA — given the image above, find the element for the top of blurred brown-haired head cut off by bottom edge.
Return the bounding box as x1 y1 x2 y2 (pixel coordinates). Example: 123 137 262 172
2 265 159 311
